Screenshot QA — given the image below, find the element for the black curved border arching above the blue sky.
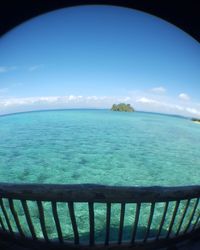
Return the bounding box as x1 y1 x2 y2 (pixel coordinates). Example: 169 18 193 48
0 0 200 42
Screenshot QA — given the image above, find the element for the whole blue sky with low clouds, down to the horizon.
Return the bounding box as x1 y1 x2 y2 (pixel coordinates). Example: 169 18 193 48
0 6 200 117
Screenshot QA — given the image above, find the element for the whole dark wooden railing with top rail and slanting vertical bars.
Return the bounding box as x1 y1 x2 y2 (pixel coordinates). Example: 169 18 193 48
0 183 200 249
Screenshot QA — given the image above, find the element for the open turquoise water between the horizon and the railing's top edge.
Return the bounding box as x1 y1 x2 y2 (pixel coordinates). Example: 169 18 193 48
0 110 200 186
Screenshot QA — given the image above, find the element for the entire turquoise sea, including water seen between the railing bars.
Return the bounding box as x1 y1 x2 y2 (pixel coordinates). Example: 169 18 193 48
0 110 200 242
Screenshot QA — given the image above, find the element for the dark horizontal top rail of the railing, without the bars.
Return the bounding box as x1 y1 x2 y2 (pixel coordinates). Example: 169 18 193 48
0 183 200 203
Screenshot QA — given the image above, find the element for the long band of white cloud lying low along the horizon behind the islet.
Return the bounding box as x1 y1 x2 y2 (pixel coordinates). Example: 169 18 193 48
0 95 200 117
